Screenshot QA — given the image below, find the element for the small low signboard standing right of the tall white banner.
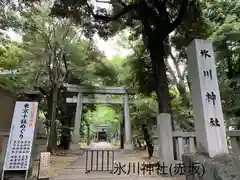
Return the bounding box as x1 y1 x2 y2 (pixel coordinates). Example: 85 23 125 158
38 152 50 179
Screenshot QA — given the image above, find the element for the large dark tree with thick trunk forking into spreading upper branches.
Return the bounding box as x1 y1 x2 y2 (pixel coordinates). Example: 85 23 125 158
49 0 203 118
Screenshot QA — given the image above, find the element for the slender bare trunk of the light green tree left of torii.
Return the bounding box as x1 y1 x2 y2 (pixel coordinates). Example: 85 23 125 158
47 84 58 153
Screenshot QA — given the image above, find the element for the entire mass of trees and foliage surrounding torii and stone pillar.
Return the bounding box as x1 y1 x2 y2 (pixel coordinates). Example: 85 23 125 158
0 0 240 151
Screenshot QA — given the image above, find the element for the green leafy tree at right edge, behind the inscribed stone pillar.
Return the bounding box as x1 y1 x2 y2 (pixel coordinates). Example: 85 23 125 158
204 0 240 128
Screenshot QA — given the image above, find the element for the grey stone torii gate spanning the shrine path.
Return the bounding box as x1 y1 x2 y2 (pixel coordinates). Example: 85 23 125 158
63 84 133 150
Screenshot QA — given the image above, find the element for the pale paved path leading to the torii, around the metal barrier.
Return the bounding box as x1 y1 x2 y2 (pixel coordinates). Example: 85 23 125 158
52 142 185 180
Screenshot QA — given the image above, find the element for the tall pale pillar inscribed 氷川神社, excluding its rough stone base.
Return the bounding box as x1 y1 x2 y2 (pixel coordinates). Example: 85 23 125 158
188 40 228 157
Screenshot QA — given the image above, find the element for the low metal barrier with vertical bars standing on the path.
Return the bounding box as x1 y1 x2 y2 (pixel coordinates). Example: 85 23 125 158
85 149 115 173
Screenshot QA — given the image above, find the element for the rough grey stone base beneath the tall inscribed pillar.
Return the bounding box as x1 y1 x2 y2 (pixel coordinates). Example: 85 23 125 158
182 153 240 180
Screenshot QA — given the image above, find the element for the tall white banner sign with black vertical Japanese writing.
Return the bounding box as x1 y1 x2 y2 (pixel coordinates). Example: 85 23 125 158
4 101 38 170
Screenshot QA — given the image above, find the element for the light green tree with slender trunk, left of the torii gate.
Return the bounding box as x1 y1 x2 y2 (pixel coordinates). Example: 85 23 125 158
11 1 112 152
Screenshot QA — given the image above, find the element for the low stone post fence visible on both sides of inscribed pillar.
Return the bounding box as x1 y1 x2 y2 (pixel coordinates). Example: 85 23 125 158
173 130 240 161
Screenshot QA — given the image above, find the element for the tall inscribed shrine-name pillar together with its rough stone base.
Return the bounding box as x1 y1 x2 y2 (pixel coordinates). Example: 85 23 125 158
182 39 240 180
